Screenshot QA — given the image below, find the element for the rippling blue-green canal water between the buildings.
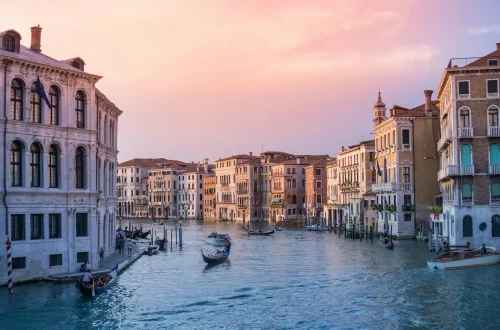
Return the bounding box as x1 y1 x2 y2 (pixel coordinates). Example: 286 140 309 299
0 221 500 330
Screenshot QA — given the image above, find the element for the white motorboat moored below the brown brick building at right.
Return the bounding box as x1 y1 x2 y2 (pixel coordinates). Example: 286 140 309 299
427 247 500 270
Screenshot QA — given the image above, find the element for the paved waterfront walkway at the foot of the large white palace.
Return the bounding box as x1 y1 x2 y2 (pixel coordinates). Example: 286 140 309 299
49 241 147 281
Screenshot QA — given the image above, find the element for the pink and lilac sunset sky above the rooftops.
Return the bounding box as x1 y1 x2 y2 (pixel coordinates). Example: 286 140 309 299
0 0 500 162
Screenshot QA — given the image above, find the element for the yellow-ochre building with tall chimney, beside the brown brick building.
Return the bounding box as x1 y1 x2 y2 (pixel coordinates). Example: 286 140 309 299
372 90 440 238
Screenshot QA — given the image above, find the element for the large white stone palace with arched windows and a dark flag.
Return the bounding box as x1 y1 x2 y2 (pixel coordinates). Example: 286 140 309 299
0 26 121 284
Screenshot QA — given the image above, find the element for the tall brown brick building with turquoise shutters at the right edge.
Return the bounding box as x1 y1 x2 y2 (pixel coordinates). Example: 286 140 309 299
437 43 500 249
